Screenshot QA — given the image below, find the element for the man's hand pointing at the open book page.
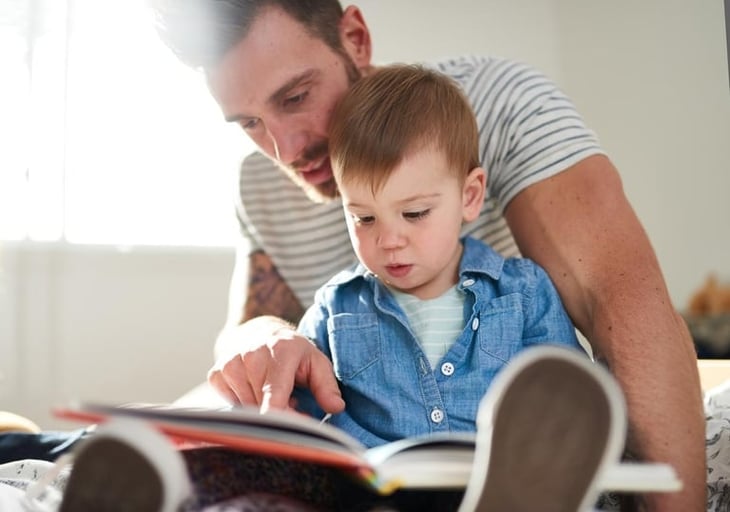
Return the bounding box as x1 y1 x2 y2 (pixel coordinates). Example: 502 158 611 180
208 317 345 413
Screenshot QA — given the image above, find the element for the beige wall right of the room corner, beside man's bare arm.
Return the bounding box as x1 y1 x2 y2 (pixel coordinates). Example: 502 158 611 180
557 0 730 308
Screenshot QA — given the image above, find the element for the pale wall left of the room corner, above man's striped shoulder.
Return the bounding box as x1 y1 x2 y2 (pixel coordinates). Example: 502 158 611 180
356 0 562 79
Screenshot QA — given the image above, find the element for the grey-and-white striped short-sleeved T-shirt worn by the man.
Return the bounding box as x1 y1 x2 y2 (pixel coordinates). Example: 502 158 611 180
236 57 602 308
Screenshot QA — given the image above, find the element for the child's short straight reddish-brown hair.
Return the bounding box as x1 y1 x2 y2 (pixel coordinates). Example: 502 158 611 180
329 64 479 191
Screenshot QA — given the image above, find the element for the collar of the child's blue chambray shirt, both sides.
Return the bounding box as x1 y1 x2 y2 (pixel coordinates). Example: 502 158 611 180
328 236 504 286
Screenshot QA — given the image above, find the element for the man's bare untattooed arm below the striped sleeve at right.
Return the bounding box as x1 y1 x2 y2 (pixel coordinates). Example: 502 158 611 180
505 155 706 512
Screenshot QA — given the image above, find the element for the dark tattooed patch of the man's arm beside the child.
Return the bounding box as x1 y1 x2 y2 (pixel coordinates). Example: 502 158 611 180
241 251 304 324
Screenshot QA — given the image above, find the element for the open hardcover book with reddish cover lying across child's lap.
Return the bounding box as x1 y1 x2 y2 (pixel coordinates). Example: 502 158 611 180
54 403 681 494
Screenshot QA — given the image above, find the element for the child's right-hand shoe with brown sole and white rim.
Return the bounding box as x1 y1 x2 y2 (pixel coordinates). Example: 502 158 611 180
460 346 626 512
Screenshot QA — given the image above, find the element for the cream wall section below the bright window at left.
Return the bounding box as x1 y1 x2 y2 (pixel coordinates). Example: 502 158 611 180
0 244 233 428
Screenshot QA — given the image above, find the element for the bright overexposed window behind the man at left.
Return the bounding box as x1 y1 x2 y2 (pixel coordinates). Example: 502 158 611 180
0 0 253 246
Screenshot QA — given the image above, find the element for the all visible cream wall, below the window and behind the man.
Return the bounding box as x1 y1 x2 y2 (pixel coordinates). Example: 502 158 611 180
0 0 730 428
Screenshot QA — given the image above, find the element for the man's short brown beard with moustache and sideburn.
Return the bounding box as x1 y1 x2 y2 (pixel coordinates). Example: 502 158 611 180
274 49 362 203
